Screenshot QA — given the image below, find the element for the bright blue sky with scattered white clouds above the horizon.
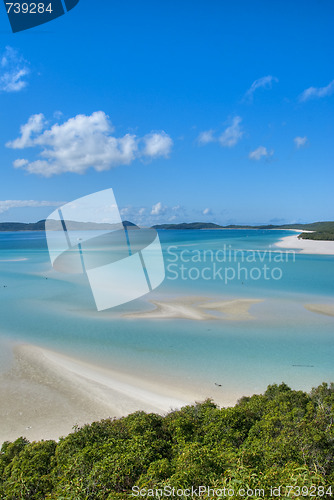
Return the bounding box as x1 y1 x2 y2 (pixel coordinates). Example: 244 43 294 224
0 0 334 224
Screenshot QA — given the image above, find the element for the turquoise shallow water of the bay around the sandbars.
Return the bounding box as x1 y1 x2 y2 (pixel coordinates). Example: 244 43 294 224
0 230 334 402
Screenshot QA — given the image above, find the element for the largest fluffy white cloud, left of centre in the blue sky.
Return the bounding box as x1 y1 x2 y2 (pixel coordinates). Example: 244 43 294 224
6 111 173 177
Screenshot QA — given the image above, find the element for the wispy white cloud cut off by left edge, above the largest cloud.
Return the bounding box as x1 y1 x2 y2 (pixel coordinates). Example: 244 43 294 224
0 47 29 92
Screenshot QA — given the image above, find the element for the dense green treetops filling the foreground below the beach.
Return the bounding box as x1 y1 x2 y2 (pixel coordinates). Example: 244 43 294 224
0 383 334 500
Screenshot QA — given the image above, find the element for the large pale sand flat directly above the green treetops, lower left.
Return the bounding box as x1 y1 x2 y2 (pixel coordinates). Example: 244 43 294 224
0 345 194 445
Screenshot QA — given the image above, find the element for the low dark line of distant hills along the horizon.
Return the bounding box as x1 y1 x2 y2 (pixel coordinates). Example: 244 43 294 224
0 220 334 241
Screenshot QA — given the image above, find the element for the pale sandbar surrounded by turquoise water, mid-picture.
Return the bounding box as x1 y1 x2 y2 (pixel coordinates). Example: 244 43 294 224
123 297 262 321
